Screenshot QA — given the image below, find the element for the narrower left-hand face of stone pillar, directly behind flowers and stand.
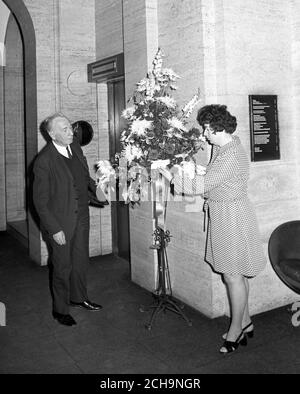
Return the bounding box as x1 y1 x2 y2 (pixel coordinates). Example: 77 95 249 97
158 0 214 316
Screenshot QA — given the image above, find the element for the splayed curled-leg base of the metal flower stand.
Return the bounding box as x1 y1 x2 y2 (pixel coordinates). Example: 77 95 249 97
140 294 192 331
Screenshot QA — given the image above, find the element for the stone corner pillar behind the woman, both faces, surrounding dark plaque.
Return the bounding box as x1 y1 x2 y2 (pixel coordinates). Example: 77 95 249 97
158 0 300 317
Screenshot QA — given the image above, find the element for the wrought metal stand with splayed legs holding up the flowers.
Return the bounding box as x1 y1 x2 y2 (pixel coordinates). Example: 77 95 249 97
140 178 192 330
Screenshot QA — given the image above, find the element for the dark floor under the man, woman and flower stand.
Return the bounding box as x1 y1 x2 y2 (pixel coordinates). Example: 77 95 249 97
0 233 300 374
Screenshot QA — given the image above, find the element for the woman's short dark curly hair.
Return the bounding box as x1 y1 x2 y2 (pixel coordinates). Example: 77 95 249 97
197 104 237 134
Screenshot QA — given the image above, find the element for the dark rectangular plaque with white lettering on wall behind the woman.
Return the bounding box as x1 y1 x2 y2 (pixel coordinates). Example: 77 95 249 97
249 95 280 161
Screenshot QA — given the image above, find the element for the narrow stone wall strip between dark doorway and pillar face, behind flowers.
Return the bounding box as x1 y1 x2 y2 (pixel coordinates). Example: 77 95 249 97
123 0 158 291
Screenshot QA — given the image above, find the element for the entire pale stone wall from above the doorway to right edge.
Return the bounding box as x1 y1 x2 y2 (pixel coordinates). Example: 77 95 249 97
96 0 300 317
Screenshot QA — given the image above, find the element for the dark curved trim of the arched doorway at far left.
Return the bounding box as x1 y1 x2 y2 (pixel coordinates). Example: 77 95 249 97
0 0 40 261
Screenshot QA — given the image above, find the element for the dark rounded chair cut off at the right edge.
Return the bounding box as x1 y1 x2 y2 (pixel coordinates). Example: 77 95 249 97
269 220 300 294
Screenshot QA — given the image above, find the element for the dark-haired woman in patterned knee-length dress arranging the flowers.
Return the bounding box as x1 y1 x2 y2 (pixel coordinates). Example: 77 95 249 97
162 104 266 354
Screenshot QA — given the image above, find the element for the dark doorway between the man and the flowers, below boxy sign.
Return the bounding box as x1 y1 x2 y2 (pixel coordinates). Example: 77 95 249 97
107 80 130 261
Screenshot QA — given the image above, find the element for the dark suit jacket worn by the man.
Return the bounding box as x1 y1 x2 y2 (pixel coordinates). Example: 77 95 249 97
33 140 96 239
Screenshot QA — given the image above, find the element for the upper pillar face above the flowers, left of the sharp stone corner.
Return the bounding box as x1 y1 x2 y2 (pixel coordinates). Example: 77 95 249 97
157 0 204 107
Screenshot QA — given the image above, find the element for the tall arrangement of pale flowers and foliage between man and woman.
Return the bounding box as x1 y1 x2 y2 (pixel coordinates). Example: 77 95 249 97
97 49 204 203
